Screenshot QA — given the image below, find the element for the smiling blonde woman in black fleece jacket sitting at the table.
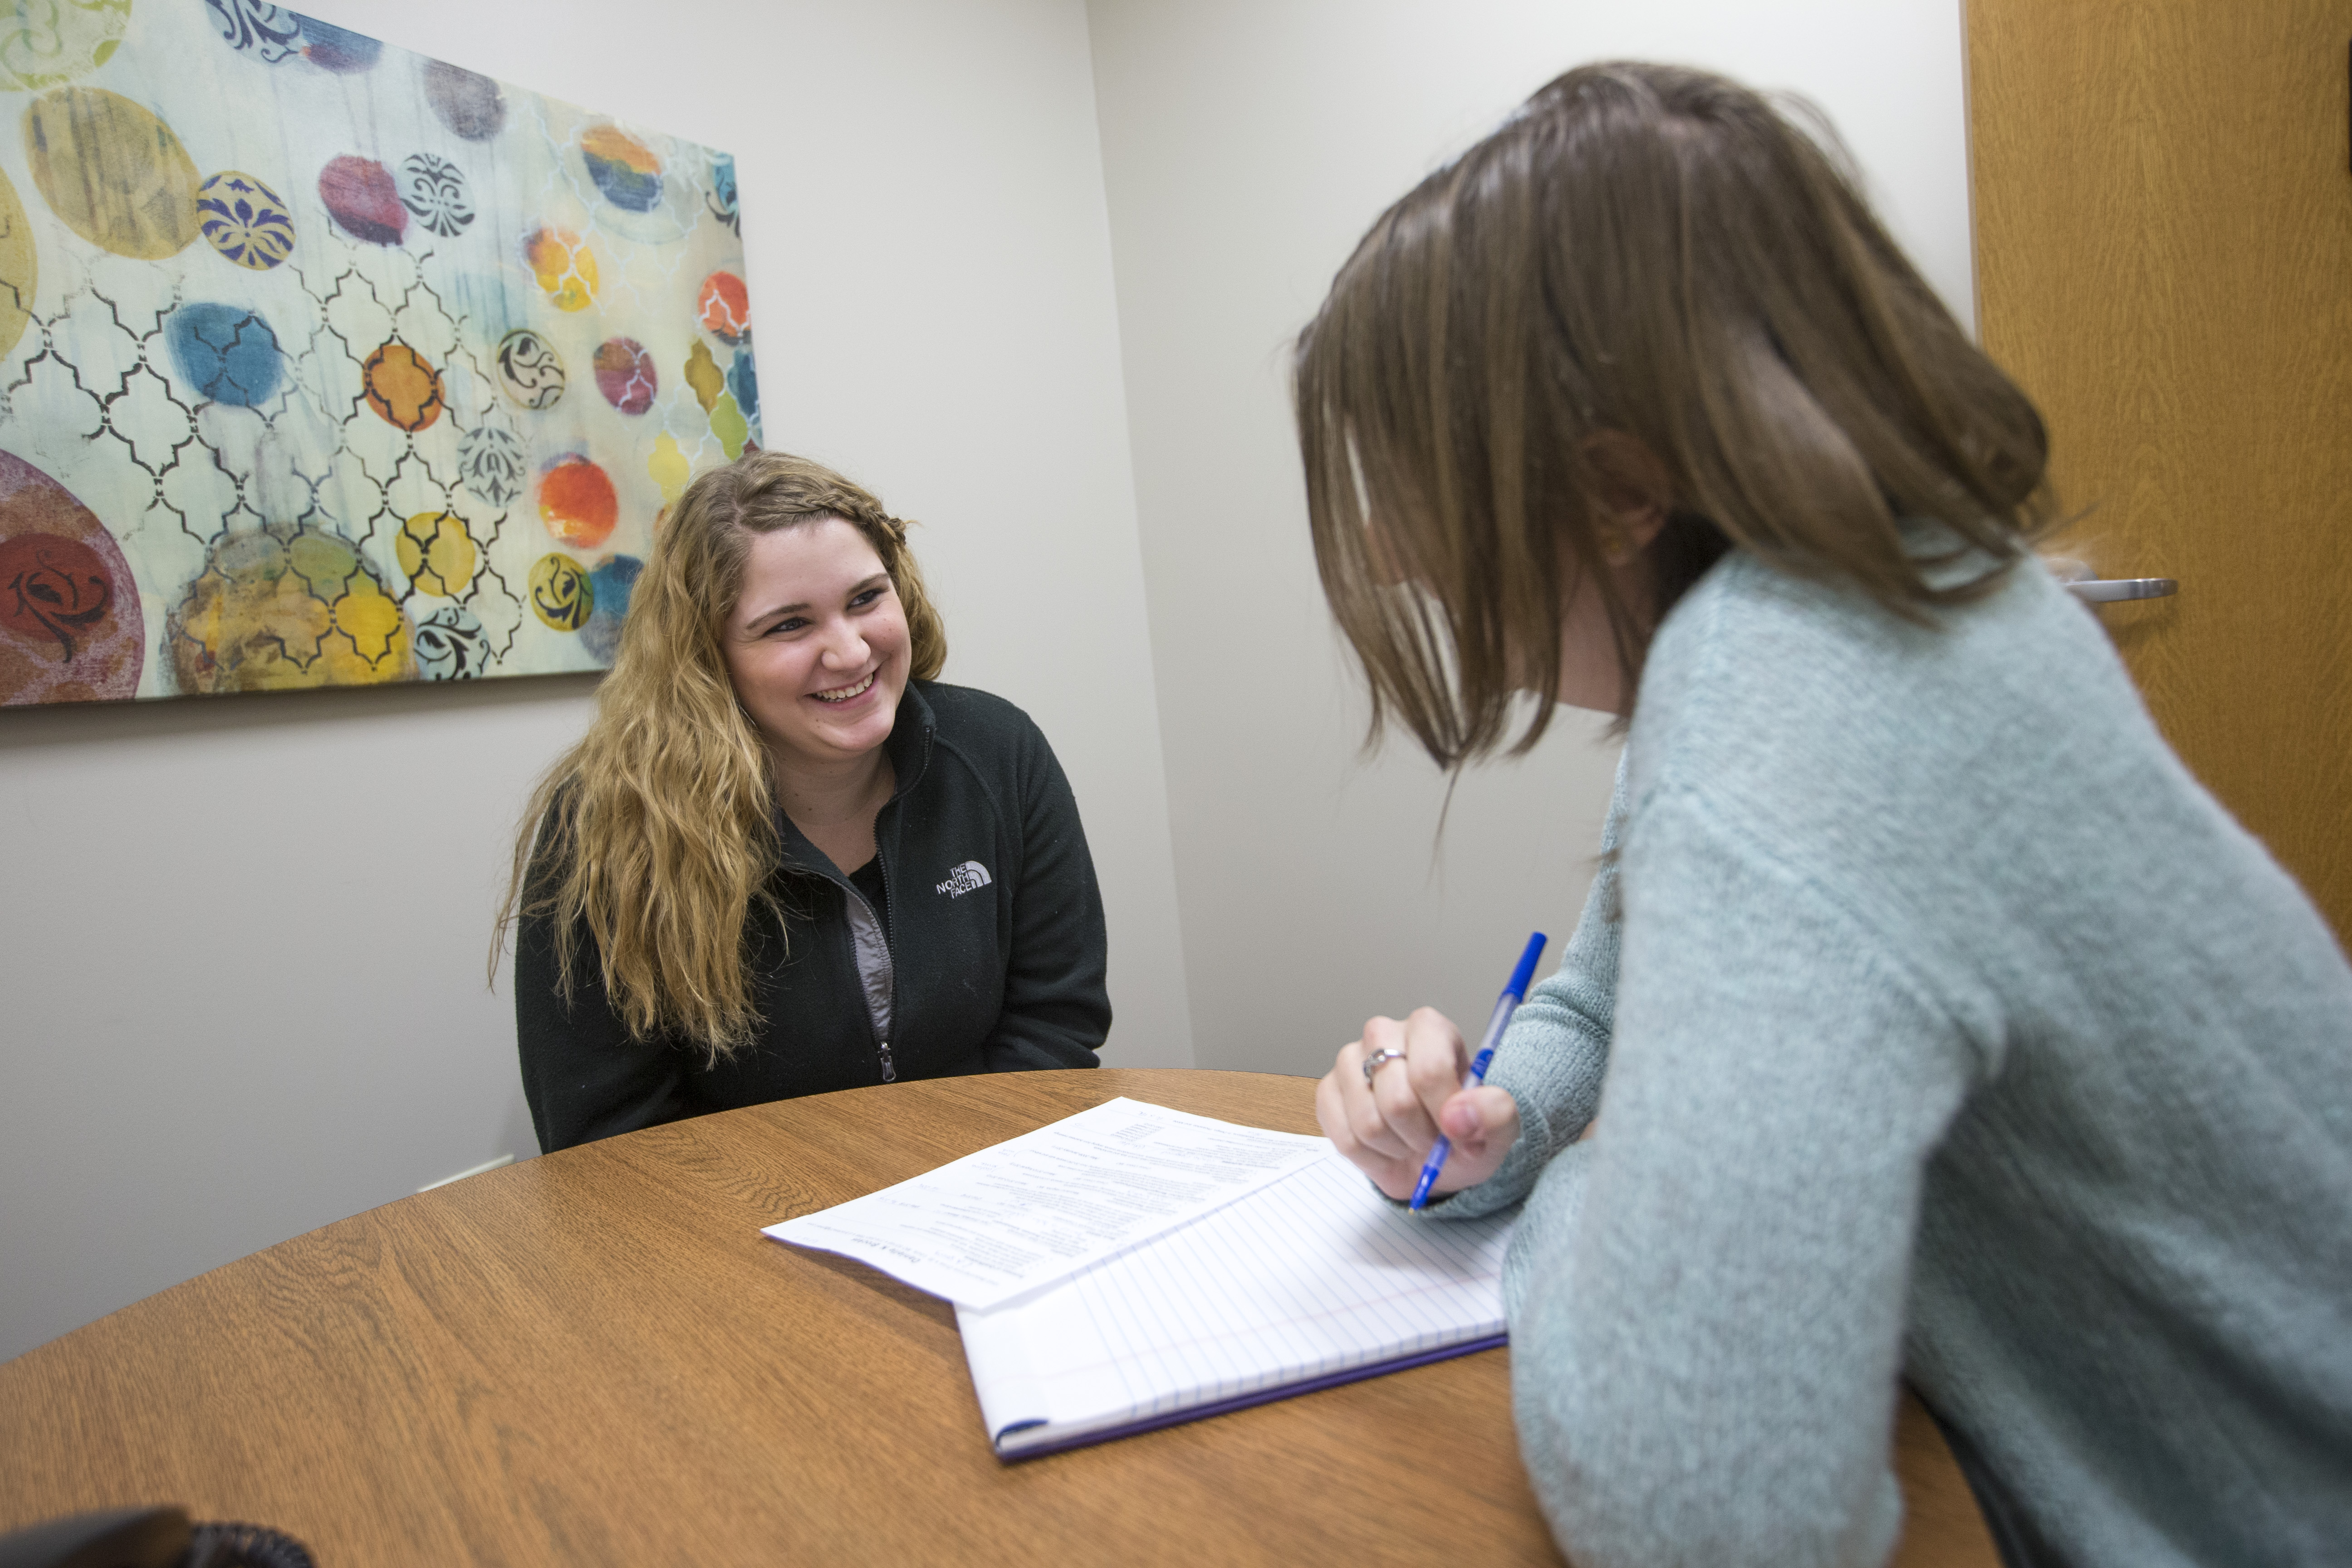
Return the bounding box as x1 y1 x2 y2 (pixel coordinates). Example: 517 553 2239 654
494 451 1110 1150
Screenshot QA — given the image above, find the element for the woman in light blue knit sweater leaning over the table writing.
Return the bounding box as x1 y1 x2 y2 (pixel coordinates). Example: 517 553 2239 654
1296 66 2352 1568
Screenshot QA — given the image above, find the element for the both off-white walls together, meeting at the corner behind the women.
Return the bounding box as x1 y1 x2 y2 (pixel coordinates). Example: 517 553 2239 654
0 0 1969 1357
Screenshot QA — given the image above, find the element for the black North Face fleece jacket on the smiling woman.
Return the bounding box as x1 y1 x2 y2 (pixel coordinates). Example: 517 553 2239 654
515 682 1110 1150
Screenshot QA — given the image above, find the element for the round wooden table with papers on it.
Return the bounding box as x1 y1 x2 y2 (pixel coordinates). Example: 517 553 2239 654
0 1070 1997 1568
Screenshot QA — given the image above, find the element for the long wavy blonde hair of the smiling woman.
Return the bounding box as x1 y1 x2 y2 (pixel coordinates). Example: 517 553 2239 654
489 451 948 1063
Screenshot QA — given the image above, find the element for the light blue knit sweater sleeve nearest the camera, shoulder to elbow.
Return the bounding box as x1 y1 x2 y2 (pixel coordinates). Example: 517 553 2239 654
1505 792 1978 1568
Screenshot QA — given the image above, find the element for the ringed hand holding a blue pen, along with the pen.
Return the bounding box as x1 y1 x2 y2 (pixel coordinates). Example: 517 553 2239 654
1315 931 1543 1201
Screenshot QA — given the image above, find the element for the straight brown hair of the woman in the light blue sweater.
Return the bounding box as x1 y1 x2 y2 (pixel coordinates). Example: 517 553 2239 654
1294 64 2051 766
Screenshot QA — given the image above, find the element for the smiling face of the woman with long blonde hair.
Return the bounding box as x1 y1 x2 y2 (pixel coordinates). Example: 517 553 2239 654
720 517 910 774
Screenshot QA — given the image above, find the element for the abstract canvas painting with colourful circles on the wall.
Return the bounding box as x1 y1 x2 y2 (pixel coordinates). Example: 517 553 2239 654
0 0 760 703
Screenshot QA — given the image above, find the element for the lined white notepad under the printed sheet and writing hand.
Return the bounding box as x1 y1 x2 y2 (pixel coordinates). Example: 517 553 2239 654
955 1152 1512 1460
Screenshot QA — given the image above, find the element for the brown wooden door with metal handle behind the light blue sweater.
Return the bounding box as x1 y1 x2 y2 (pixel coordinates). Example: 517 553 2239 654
1966 0 2352 945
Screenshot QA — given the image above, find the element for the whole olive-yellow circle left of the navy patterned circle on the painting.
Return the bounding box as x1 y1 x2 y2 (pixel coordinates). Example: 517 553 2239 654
24 87 202 261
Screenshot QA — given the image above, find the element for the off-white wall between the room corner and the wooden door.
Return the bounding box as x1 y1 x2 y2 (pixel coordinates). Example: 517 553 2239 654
1089 0 1971 1072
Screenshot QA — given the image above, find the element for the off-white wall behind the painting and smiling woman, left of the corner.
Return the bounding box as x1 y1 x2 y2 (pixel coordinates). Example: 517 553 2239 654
0 0 1190 1359
